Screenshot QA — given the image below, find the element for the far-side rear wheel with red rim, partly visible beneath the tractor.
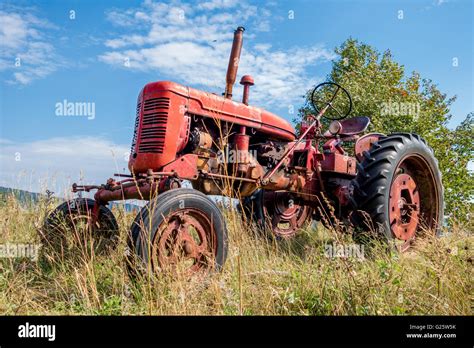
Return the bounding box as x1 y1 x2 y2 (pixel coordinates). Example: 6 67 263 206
243 190 312 239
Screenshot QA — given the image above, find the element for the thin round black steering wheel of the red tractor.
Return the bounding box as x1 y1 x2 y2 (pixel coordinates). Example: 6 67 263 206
310 82 352 120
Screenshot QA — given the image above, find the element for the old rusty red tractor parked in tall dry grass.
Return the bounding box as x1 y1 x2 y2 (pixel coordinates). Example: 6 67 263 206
43 27 443 272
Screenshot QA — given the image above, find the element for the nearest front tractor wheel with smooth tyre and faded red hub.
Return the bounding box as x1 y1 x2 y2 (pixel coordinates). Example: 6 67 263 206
129 188 227 276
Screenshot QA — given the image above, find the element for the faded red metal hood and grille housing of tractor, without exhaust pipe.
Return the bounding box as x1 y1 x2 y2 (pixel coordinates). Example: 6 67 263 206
128 81 295 174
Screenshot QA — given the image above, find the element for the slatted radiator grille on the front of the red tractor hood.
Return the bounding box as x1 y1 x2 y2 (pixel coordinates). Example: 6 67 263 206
138 98 170 153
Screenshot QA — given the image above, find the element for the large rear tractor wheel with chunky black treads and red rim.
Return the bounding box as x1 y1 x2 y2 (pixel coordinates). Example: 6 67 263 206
353 133 444 251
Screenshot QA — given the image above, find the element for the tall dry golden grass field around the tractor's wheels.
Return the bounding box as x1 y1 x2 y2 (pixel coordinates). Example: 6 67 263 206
0 197 474 315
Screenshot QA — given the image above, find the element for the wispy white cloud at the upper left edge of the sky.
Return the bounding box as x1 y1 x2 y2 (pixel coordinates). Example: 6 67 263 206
0 8 63 85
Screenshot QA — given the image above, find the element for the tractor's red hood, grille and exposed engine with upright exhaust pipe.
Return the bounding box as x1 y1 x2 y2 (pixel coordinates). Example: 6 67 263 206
125 27 296 196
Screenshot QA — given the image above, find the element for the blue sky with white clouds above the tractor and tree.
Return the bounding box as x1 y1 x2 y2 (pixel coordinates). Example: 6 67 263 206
0 0 474 191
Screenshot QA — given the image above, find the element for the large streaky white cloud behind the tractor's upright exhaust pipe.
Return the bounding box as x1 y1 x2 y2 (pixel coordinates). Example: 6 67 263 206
99 0 334 108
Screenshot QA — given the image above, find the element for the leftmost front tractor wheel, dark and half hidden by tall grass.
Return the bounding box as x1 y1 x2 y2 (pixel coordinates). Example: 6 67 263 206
41 198 120 257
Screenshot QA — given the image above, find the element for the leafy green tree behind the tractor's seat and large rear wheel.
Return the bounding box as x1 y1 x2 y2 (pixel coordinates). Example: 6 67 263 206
297 38 474 221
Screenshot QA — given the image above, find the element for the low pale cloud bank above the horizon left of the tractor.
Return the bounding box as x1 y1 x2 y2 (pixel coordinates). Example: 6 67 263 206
0 136 129 196
